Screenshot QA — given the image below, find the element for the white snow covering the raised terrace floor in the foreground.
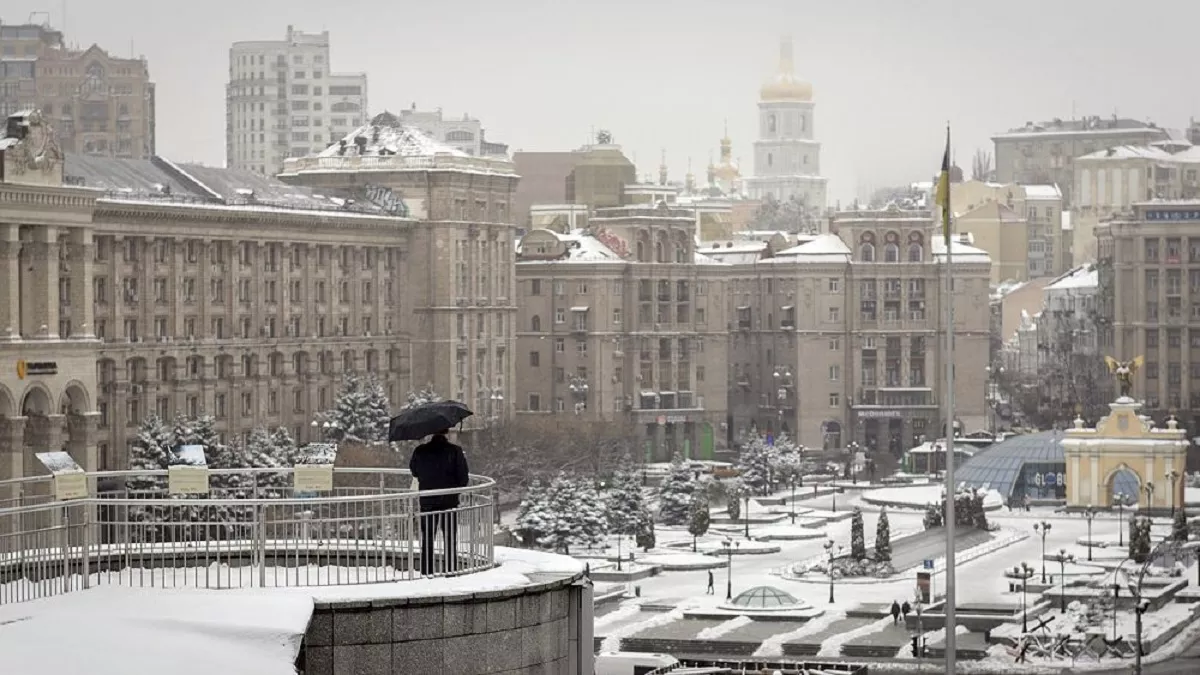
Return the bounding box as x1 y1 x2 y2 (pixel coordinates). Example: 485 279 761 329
0 548 583 675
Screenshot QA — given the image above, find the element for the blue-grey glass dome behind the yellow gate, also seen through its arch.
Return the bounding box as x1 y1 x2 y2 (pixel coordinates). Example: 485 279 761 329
954 431 1138 501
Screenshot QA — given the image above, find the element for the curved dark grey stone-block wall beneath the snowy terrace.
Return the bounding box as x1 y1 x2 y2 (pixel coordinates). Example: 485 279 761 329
299 566 592 675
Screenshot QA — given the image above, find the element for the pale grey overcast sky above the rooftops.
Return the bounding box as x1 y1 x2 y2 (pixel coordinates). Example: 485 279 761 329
9 0 1200 202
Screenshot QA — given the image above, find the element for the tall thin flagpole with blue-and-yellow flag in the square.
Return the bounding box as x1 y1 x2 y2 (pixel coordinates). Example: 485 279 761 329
942 124 958 673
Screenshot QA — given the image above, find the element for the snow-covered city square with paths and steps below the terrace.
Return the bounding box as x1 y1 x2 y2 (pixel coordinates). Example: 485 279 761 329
585 485 1200 671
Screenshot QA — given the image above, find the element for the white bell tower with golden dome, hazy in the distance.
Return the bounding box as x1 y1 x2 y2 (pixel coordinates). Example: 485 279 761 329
745 38 827 210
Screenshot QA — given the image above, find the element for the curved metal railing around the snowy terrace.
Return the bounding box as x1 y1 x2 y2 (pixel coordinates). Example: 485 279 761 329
0 467 496 605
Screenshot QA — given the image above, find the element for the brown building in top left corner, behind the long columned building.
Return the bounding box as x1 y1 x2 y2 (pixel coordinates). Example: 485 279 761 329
0 24 155 159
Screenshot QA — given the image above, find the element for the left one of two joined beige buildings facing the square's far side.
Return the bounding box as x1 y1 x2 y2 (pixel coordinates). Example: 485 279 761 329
516 201 728 460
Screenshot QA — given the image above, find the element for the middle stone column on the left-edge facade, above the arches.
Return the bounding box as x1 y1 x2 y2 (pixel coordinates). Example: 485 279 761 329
20 225 59 340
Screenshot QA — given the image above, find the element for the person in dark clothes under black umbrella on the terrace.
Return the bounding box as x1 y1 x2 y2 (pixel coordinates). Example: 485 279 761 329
388 401 473 574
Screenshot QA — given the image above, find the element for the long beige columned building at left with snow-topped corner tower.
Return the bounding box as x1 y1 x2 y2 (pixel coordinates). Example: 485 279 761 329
0 110 516 478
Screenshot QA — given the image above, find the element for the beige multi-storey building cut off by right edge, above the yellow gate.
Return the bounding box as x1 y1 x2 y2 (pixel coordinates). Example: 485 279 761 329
1096 199 1200 417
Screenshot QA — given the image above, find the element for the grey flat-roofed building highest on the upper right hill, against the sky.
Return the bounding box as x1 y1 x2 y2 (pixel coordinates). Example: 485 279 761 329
991 115 1170 209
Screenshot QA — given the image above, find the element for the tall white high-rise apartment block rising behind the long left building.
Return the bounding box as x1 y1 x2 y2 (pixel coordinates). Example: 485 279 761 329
226 25 367 175
